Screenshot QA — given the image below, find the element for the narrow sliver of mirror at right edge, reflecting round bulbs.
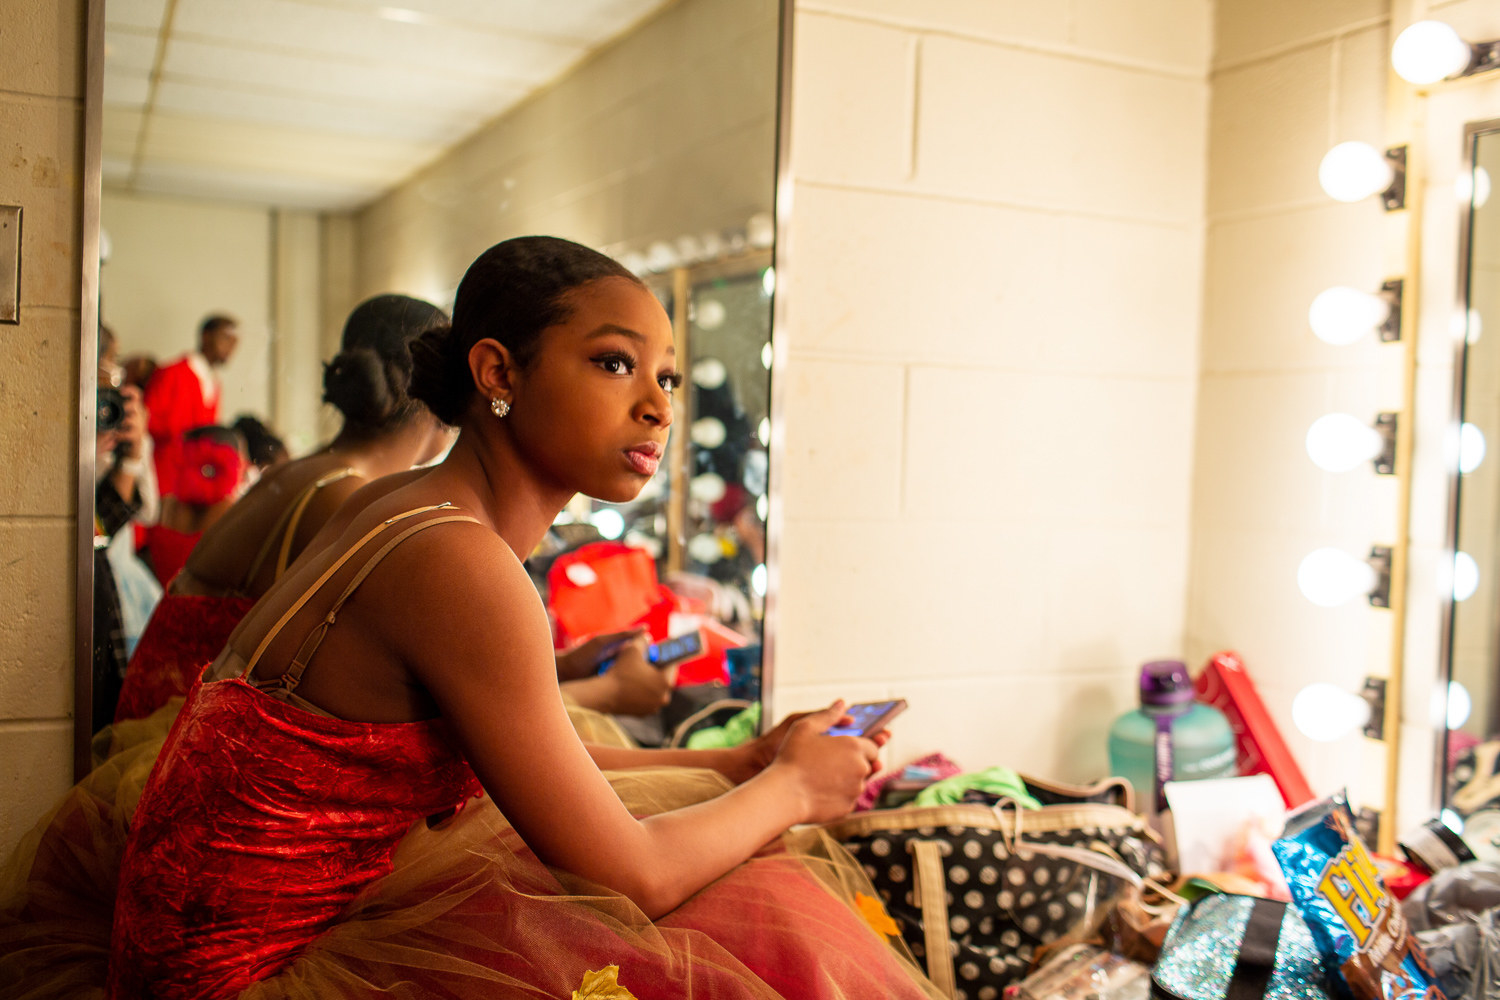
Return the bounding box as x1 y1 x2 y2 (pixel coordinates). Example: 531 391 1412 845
1445 121 1500 846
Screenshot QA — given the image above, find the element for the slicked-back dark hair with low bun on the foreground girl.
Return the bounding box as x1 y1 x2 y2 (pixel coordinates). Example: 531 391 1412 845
410 235 641 424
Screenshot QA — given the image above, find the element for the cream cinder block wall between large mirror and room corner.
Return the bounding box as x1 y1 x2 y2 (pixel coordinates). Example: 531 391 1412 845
773 0 1212 780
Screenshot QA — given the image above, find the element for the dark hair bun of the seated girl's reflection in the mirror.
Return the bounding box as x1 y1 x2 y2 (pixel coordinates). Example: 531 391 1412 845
323 295 449 432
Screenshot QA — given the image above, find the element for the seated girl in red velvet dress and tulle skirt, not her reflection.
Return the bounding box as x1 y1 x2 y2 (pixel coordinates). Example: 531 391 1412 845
110 237 938 1000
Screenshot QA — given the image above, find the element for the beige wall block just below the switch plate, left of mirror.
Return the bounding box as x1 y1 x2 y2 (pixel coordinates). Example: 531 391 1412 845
0 309 78 519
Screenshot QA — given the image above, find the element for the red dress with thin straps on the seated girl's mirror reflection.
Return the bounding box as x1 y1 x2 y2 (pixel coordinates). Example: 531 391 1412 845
114 469 359 723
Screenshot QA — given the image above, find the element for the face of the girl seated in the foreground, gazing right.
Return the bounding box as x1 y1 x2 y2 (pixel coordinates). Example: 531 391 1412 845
506 277 683 502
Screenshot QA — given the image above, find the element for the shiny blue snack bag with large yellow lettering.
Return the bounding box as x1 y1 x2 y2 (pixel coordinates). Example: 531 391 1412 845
1271 792 1446 1000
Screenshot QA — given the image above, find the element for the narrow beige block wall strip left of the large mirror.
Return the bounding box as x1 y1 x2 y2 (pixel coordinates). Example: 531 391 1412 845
0 0 86 856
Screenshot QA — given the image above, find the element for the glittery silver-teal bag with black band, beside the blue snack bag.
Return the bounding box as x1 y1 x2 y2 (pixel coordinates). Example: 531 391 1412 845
1151 894 1335 1000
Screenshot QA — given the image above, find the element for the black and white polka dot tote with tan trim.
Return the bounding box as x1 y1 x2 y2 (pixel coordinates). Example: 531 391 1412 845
825 799 1166 1000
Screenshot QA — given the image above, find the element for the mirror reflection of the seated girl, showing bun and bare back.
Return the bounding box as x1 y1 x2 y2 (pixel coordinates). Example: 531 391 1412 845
116 295 452 721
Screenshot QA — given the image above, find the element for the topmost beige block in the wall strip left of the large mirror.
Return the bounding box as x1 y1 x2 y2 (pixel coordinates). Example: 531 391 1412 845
0 0 87 99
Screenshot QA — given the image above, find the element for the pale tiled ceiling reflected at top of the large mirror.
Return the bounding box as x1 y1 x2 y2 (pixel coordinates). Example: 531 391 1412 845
102 0 672 211
